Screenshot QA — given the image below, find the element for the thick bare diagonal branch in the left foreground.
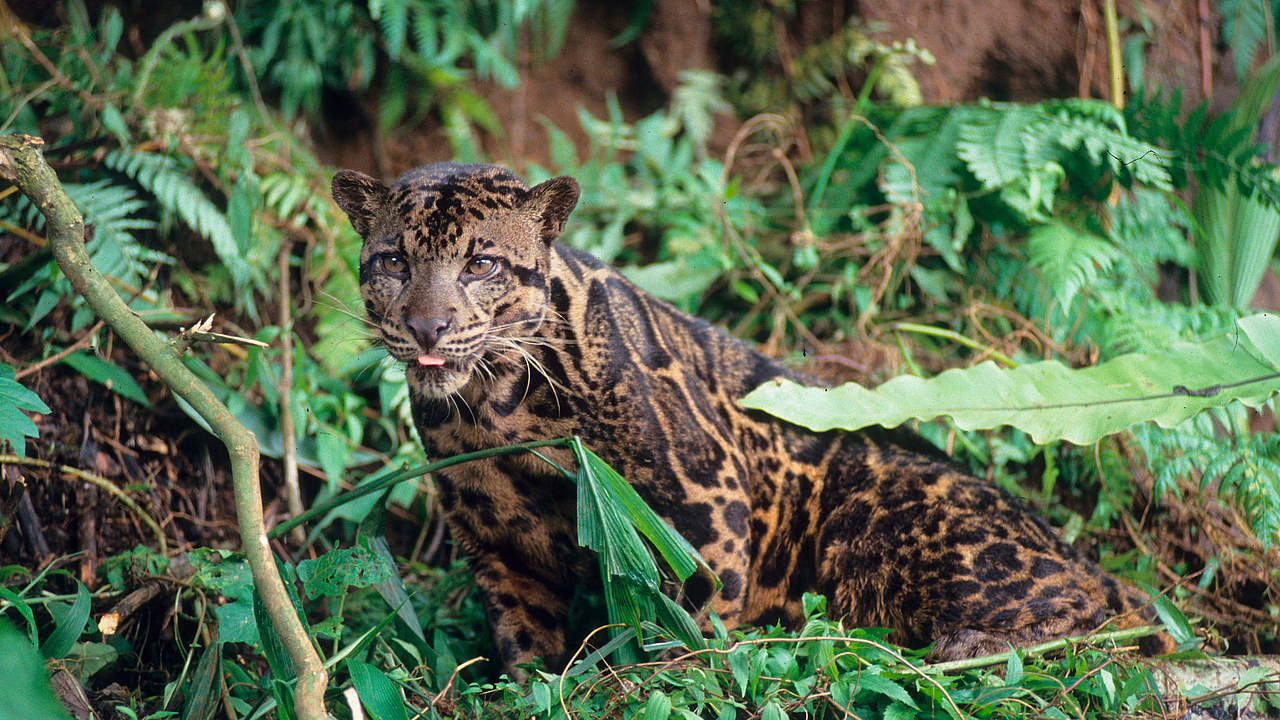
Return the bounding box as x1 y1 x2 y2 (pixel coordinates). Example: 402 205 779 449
0 135 329 720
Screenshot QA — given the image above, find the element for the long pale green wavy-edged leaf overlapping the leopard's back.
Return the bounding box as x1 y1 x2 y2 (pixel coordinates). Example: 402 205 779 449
739 318 1280 445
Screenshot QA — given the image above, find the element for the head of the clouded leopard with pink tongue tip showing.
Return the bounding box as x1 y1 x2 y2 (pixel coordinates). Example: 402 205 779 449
332 163 579 398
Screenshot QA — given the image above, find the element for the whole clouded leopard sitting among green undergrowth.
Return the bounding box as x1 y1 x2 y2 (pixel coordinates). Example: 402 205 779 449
333 164 1172 667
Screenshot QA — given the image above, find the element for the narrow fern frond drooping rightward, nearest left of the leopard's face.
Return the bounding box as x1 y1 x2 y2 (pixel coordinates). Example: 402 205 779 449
102 149 252 286
